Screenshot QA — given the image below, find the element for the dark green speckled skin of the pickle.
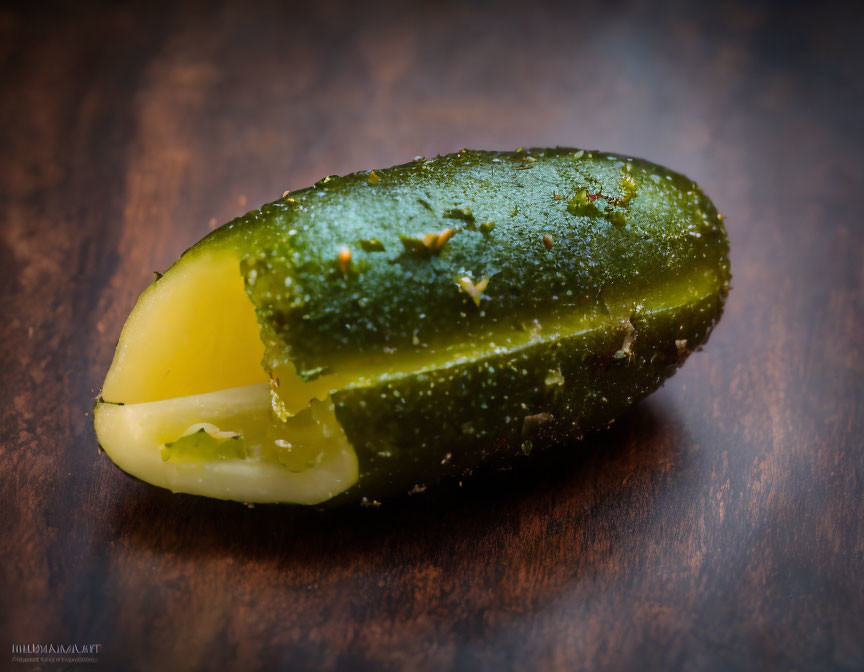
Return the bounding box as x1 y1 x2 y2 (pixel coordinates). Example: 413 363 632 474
196 148 731 502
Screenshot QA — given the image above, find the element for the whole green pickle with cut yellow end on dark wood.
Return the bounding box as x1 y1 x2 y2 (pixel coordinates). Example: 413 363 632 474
96 148 730 505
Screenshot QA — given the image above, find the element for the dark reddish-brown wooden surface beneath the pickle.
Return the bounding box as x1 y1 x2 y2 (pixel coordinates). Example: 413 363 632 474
0 1 864 671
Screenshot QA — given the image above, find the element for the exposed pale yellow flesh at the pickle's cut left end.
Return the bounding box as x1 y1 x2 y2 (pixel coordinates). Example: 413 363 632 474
96 251 358 504
